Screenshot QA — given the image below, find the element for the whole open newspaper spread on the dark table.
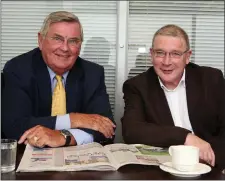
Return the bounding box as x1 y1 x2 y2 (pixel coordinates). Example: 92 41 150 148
17 142 171 172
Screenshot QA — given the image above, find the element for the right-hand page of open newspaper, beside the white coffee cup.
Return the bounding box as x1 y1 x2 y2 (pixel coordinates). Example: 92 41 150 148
105 144 171 169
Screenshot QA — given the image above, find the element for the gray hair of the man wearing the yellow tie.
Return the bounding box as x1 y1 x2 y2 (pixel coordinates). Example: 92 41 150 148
40 11 84 42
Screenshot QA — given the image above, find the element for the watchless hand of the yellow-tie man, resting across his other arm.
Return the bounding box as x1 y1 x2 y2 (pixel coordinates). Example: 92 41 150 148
70 113 116 138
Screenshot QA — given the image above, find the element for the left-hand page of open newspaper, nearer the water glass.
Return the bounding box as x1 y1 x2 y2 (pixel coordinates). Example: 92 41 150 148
17 143 115 172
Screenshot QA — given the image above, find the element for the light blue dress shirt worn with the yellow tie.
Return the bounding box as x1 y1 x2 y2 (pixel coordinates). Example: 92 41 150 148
48 67 94 145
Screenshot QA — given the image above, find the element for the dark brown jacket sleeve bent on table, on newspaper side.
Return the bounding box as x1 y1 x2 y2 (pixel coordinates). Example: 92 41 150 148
121 80 190 147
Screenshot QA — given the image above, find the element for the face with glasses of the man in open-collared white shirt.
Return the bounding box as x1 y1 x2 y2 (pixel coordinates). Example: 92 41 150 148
151 35 191 89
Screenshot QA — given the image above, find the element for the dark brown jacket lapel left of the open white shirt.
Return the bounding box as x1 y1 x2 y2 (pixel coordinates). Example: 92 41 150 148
147 67 174 126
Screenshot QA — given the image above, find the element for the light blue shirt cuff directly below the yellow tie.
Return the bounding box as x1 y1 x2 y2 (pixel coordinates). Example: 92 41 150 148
55 114 71 130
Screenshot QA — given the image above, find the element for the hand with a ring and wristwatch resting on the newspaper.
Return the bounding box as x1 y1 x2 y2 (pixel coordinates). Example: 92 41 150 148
18 125 65 148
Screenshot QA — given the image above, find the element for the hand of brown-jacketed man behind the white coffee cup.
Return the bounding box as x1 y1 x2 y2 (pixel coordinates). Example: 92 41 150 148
184 133 215 166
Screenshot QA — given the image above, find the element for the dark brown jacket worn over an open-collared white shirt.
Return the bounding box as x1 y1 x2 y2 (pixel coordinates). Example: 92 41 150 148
121 63 225 168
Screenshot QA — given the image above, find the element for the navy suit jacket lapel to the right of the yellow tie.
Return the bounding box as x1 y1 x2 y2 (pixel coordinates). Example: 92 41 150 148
66 57 83 113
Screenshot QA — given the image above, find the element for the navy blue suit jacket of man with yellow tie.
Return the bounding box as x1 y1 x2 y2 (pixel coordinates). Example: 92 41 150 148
2 48 116 143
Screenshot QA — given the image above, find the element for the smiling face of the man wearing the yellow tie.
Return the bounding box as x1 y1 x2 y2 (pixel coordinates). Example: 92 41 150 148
38 22 81 75
